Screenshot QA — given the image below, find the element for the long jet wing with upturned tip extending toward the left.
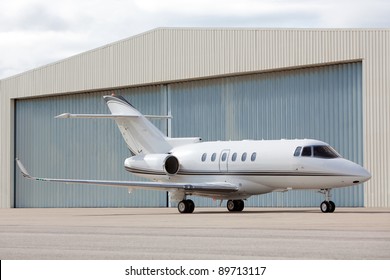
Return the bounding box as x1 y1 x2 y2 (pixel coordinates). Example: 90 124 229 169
16 159 239 195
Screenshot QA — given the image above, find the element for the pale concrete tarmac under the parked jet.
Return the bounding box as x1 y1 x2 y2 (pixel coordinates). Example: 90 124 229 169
0 207 390 260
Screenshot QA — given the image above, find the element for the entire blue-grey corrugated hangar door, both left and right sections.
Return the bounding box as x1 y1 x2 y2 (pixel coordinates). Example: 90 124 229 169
15 63 364 207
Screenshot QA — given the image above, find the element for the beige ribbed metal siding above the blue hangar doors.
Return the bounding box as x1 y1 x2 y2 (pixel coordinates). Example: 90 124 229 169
4 28 380 97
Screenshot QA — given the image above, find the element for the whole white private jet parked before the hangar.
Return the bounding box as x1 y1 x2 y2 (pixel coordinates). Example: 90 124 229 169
16 95 371 213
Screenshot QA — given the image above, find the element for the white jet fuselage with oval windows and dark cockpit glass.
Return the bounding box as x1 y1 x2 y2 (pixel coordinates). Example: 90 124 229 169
125 139 371 199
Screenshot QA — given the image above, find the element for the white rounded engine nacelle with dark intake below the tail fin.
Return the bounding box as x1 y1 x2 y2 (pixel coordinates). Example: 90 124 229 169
125 154 180 175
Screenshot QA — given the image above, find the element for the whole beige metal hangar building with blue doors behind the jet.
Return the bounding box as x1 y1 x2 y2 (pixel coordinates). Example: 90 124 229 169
0 28 390 208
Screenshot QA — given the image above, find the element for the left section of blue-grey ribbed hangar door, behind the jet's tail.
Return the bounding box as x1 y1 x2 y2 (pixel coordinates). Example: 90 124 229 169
15 86 166 207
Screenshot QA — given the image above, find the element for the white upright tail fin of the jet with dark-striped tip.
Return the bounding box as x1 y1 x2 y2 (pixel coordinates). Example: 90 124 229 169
103 96 172 155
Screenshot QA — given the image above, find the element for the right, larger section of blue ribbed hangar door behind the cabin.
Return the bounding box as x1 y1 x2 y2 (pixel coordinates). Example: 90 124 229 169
169 62 364 207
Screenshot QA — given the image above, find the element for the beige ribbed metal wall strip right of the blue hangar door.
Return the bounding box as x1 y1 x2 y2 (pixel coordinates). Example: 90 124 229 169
363 30 390 207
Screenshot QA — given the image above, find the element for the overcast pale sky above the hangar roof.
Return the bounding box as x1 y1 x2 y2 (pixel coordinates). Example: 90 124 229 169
0 0 390 79
